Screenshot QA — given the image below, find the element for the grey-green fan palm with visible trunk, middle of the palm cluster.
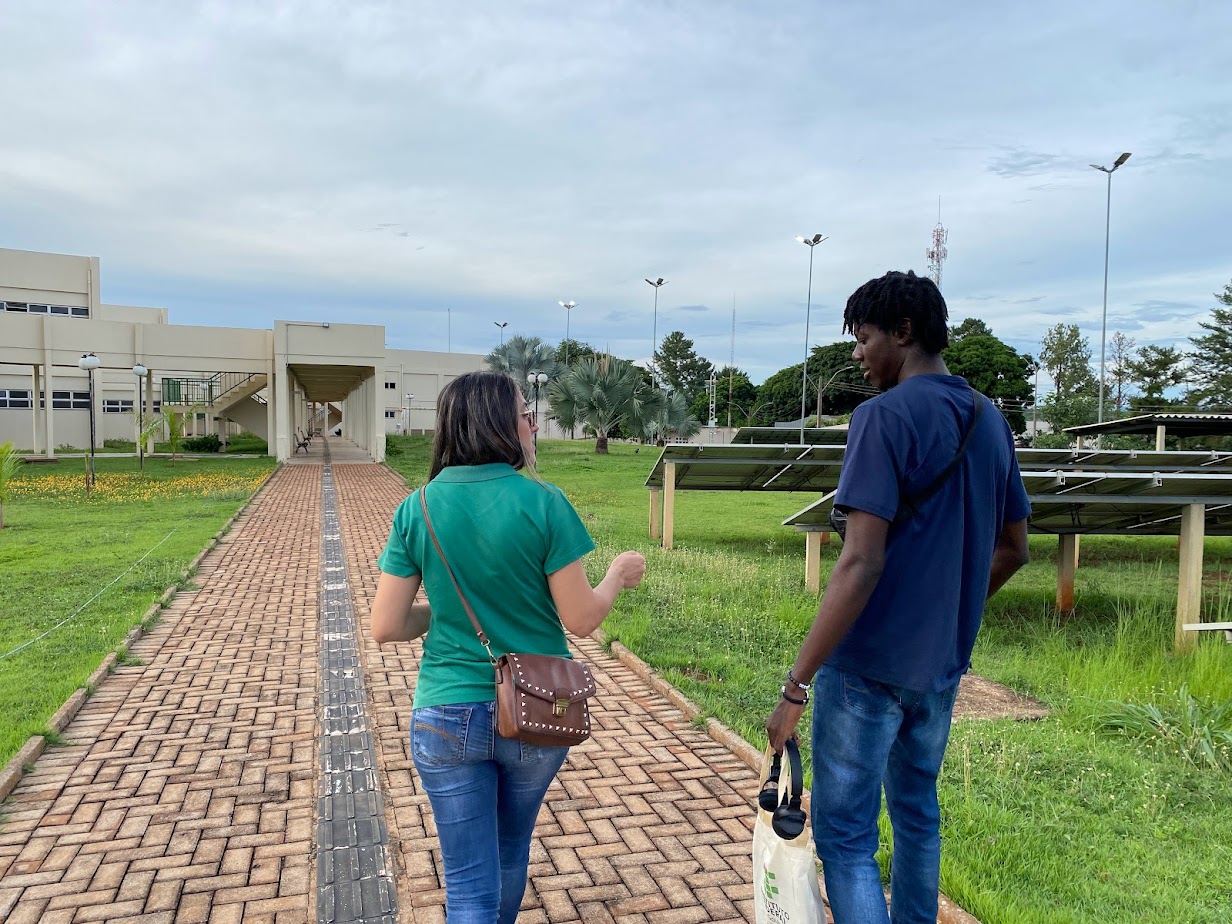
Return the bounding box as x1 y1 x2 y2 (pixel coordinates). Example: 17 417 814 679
547 355 663 455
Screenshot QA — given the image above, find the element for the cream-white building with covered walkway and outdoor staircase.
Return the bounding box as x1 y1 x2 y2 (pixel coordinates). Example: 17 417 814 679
0 249 484 462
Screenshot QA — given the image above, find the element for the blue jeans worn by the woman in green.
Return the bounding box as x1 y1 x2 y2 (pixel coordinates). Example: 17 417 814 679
410 702 569 924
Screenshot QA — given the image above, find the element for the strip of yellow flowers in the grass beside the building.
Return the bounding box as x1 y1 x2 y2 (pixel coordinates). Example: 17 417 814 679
11 472 267 504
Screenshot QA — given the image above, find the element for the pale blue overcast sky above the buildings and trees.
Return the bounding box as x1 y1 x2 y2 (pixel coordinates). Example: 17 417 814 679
0 0 1232 382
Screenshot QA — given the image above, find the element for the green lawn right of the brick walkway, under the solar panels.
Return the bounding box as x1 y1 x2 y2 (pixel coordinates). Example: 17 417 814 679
389 436 1232 924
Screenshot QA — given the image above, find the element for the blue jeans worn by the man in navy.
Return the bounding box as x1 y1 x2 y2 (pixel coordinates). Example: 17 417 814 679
812 667 958 924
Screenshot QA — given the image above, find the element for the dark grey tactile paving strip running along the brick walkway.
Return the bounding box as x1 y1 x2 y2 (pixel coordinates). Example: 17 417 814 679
317 444 398 924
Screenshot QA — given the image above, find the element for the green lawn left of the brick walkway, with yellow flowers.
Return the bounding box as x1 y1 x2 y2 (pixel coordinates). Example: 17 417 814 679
0 456 274 766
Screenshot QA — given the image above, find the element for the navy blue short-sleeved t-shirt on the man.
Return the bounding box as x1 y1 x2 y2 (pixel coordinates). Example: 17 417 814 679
825 375 1031 692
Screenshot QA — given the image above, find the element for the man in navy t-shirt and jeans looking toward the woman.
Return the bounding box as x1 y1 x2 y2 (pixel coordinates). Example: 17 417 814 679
766 272 1030 924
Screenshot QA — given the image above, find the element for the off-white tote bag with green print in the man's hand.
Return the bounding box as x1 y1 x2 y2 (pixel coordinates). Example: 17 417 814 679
753 742 825 924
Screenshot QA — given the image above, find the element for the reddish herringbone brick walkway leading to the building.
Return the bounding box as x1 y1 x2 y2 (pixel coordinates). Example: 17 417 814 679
0 464 756 924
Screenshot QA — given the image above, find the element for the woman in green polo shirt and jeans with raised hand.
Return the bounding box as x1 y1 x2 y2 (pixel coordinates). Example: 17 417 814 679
372 372 646 924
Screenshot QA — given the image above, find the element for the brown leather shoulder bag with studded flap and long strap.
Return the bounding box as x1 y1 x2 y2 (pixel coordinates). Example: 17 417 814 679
419 484 595 747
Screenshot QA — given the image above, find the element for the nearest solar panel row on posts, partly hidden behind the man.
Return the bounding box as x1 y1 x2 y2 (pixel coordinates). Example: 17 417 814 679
784 471 1232 652
